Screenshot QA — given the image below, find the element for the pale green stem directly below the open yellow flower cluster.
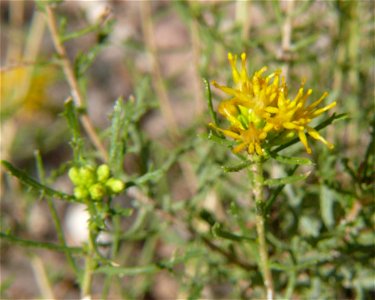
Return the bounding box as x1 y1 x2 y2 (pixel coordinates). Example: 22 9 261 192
250 159 275 300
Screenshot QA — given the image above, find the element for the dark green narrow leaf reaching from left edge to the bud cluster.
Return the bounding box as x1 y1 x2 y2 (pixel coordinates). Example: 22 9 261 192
1 160 78 202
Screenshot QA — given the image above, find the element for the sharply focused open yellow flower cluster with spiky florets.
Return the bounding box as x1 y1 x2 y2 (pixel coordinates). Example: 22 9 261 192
210 53 336 155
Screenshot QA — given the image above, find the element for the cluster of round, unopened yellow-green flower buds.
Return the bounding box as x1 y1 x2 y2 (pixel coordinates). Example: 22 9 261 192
68 164 125 200
